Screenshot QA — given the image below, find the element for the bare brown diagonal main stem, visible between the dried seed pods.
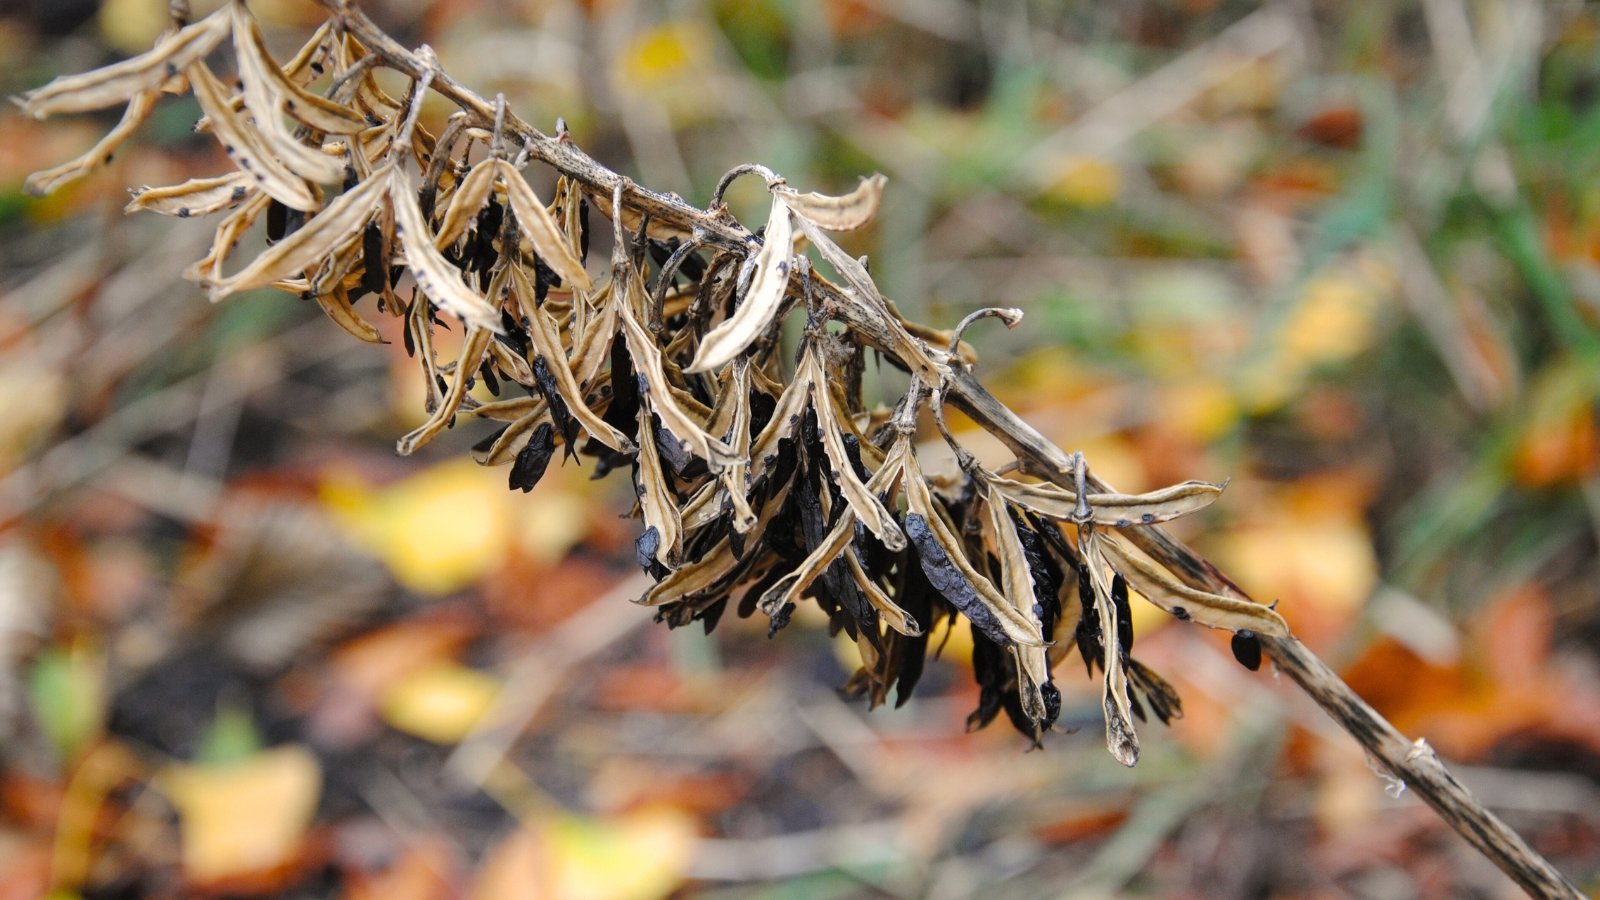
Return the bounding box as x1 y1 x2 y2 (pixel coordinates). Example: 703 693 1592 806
318 0 1582 898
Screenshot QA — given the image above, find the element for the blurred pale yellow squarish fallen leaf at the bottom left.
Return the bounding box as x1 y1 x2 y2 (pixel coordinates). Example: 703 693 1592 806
157 745 322 884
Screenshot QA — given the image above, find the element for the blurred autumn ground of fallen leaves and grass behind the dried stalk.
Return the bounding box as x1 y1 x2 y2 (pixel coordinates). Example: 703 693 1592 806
0 0 1600 898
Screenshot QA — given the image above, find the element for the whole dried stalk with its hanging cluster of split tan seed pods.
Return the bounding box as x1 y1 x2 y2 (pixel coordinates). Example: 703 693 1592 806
22 0 1578 897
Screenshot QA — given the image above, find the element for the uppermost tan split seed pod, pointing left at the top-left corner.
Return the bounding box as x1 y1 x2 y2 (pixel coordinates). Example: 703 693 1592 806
22 10 227 119
